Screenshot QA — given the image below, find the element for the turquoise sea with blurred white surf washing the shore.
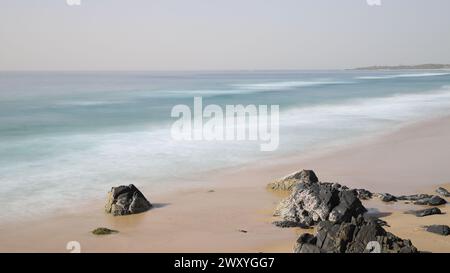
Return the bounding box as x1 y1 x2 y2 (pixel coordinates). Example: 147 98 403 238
0 71 450 222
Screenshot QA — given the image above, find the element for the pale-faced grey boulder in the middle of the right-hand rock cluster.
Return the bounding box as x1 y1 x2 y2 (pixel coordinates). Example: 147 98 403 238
274 178 366 227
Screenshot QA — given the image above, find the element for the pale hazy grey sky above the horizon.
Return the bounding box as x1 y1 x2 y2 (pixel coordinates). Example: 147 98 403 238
0 0 450 70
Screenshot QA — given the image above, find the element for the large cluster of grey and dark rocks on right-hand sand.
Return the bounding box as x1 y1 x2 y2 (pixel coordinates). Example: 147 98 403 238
269 170 426 253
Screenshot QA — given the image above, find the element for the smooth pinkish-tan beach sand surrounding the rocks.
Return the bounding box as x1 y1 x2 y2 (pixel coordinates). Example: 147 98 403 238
0 118 450 252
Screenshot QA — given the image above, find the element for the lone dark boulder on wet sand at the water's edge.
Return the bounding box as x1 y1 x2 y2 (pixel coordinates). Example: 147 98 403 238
105 185 152 216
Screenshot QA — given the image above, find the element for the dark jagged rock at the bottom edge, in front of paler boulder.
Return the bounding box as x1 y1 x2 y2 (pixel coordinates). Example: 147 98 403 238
294 216 418 253
